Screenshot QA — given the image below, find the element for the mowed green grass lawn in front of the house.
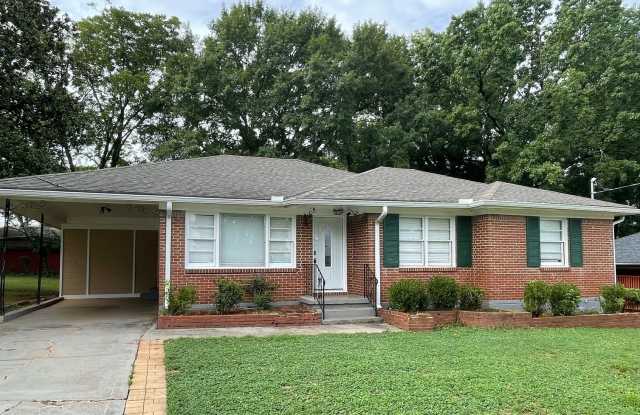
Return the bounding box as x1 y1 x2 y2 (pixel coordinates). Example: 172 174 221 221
165 328 640 415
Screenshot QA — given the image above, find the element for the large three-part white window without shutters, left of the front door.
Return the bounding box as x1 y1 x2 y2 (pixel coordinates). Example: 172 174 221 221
185 212 295 269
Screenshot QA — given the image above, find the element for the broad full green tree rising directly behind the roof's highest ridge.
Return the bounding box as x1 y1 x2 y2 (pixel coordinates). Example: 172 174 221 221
149 2 343 163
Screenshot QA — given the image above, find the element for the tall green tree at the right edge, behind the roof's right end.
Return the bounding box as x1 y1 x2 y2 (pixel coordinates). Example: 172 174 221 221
490 0 640 204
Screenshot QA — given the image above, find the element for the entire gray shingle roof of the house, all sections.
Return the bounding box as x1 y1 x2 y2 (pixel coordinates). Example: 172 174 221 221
0 155 640 214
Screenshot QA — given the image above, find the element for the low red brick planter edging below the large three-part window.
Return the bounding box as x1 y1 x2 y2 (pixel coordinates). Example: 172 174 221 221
157 311 321 329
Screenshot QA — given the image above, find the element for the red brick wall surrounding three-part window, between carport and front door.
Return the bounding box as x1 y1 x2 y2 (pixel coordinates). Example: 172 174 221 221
159 211 313 304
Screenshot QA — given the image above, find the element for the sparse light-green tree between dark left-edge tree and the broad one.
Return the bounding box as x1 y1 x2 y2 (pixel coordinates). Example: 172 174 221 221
73 7 193 168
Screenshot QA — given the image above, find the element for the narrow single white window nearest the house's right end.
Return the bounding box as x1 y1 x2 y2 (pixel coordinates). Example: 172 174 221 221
540 218 569 267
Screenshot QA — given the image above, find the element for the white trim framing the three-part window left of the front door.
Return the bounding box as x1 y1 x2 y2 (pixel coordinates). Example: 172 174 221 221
184 212 297 270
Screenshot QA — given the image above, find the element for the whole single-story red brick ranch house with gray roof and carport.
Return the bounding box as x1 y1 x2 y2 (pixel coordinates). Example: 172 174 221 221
0 155 640 320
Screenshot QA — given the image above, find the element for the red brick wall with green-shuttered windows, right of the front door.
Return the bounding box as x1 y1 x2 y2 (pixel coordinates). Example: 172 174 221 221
380 215 614 302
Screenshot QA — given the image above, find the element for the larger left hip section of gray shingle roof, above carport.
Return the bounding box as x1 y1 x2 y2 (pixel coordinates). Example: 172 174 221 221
0 155 353 200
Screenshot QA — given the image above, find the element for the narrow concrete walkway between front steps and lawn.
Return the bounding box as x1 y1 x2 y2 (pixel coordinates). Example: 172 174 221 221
143 323 400 340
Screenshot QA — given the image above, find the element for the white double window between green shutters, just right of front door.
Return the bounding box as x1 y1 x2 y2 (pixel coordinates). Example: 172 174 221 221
399 216 455 267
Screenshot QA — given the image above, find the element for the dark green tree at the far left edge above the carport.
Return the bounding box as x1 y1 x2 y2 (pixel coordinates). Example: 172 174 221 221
0 0 81 177
